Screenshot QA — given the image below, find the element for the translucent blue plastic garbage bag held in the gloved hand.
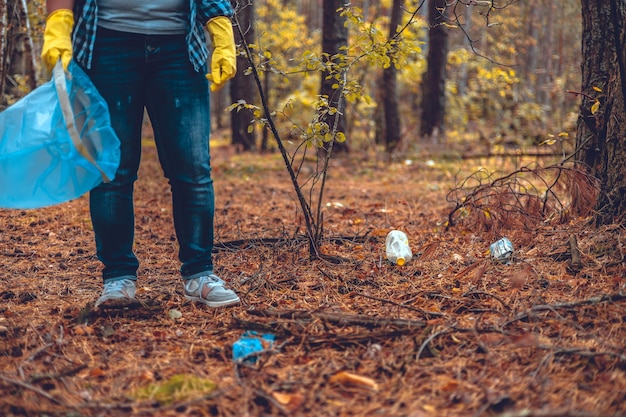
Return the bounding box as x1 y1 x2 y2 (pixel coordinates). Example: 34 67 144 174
0 62 120 209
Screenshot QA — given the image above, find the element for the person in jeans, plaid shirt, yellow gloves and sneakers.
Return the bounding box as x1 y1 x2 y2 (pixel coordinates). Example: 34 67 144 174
41 0 240 308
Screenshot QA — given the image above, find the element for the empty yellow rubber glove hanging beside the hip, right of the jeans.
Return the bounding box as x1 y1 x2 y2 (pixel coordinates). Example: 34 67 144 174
206 16 237 91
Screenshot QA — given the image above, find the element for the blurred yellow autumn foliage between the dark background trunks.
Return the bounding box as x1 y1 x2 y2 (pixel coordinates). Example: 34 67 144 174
0 0 581 152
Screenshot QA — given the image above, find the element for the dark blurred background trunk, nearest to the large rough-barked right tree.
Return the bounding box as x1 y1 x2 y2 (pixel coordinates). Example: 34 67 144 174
420 0 448 139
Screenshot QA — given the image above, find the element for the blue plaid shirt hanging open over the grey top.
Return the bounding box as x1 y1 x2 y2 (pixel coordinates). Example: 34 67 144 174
72 0 233 71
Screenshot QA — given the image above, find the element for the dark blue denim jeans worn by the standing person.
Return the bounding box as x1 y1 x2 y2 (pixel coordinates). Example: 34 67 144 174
85 28 215 282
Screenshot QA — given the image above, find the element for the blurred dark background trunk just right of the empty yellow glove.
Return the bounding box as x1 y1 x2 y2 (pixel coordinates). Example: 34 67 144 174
230 0 256 151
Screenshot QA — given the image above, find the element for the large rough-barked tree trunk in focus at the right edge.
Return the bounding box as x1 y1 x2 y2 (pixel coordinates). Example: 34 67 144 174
576 0 626 225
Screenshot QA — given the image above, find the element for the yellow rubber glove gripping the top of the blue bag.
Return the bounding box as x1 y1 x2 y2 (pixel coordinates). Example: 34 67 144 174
41 9 74 71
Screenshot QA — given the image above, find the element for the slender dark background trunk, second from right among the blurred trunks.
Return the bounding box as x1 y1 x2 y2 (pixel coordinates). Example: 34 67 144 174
380 0 404 152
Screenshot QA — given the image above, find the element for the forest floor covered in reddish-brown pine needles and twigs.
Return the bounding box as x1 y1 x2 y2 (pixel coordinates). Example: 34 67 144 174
0 134 626 417
